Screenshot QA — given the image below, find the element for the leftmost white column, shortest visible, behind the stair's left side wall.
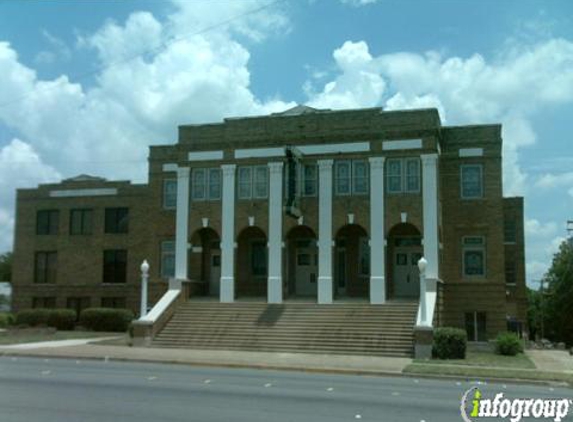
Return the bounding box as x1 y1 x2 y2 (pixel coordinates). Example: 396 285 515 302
175 167 190 284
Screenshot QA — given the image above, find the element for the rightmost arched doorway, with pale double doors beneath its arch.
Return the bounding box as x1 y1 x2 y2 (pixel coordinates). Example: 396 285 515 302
387 223 423 299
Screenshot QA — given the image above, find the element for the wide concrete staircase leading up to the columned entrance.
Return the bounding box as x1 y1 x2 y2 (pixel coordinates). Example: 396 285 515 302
152 301 418 357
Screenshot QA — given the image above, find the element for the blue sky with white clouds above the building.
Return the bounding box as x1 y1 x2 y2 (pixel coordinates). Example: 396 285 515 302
0 0 573 287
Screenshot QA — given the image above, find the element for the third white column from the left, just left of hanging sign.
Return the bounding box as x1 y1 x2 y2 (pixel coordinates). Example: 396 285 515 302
267 162 283 303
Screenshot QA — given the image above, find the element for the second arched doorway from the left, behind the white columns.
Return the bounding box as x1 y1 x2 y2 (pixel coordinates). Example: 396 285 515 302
235 226 268 297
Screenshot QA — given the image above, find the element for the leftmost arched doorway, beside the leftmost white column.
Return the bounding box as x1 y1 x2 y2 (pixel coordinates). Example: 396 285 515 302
189 227 221 296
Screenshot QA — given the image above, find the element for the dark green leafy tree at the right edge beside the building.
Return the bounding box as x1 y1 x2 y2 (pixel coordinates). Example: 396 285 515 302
543 242 573 345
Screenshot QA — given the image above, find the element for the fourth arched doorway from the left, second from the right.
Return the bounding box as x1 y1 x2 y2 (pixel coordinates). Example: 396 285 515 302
334 224 370 298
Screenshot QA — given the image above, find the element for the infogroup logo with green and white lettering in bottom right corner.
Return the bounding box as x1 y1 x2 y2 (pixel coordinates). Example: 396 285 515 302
460 387 573 422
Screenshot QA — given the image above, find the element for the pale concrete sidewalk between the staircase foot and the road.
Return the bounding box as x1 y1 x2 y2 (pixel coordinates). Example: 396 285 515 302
0 338 412 375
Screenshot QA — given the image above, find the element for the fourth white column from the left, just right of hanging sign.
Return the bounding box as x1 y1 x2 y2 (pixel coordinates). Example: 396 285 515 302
318 160 332 304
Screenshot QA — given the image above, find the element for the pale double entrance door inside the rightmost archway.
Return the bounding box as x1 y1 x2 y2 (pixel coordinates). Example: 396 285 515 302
393 246 422 298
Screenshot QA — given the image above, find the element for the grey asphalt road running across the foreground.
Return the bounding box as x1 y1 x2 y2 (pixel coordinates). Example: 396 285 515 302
0 356 573 422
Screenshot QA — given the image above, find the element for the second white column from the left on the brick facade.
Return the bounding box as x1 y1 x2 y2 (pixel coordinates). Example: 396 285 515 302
219 164 237 303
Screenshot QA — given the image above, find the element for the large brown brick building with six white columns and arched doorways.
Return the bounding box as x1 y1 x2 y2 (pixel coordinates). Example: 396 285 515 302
13 106 526 340
